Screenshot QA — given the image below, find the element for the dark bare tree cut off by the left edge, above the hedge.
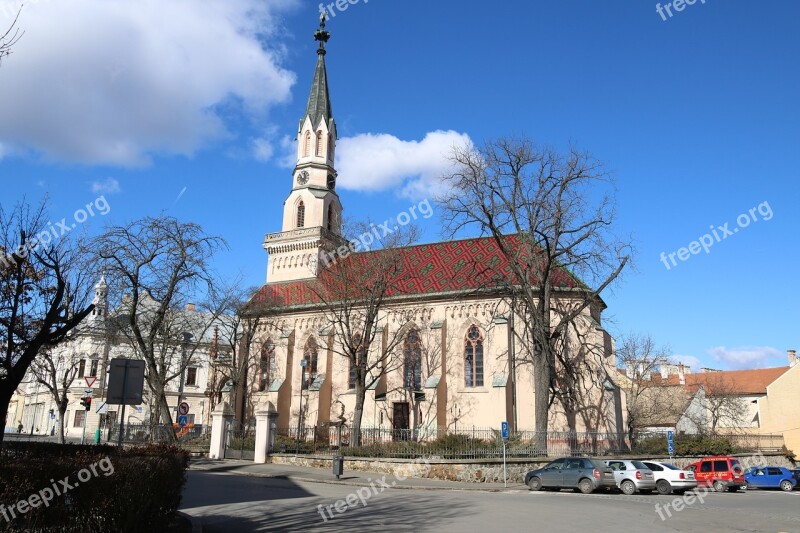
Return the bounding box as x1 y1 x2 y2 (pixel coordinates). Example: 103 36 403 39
0 202 94 443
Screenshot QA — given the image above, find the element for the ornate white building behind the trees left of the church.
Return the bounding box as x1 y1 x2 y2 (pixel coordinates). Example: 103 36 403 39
20 278 219 439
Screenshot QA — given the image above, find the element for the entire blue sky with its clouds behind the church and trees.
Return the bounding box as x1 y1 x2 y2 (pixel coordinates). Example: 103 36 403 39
0 0 800 368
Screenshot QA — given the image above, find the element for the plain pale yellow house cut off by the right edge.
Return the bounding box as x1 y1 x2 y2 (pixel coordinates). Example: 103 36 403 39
758 350 800 453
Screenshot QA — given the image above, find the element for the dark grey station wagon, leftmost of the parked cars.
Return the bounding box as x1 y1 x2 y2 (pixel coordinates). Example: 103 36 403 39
525 457 616 494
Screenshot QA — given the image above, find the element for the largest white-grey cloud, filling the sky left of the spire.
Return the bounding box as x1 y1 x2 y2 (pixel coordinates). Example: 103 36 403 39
0 0 298 166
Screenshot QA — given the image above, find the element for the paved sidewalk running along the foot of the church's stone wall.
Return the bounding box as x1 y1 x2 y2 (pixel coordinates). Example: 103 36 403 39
189 459 528 492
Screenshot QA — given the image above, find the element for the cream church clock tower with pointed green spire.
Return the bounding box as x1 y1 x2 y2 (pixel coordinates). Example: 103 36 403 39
264 14 342 283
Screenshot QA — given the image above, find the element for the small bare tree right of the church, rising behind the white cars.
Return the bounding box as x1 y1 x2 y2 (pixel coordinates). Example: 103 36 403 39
617 333 670 446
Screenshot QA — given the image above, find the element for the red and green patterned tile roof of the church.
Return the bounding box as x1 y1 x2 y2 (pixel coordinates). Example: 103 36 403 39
251 236 579 308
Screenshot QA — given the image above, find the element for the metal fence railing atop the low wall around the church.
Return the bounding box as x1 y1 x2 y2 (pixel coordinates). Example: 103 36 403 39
270 426 783 459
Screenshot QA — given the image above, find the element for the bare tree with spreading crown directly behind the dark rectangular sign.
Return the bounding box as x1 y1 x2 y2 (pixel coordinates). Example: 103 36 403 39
94 216 225 432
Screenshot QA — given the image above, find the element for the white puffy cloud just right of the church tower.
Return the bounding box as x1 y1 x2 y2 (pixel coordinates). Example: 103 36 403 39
336 131 472 199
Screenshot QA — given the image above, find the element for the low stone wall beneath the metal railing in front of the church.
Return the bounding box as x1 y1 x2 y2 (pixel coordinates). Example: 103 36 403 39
268 454 794 483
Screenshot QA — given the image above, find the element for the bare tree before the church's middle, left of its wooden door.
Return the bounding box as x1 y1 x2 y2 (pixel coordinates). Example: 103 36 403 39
310 223 421 446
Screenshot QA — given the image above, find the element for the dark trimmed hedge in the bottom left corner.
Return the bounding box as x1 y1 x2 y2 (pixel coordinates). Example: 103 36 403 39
0 442 189 533
